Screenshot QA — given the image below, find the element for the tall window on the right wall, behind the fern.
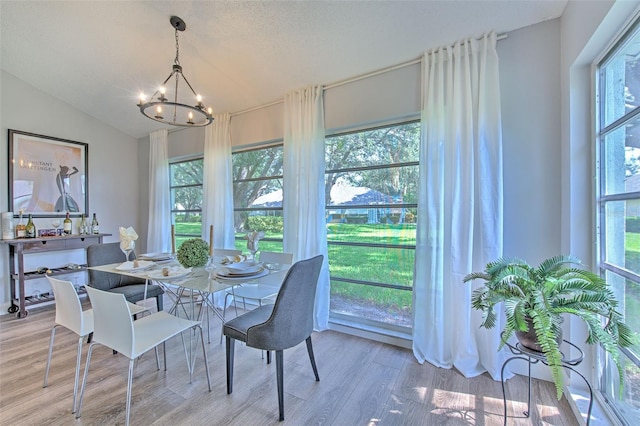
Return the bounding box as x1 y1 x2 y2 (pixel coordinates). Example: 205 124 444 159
596 16 640 423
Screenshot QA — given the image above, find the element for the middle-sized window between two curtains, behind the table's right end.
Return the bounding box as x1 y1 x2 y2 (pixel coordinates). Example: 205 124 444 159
232 144 283 252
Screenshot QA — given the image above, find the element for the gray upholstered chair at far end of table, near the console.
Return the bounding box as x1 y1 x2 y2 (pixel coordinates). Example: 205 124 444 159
87 242 164 312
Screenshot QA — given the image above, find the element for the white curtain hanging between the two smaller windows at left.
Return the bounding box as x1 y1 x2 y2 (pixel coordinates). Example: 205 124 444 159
202 113 235 250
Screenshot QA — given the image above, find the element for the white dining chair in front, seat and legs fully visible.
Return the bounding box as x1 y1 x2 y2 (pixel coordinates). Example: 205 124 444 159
76 288 211 426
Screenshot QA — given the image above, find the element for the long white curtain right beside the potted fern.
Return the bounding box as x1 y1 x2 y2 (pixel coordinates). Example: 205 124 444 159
413 33 506 379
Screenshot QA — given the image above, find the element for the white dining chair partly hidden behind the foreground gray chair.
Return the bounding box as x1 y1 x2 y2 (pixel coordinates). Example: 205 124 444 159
220 251 293 343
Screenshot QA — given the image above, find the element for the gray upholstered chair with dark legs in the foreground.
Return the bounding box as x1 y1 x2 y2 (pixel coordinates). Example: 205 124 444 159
223 255 323 421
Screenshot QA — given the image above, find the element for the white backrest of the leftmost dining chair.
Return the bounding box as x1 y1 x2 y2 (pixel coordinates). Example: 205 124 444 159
47 277 93 336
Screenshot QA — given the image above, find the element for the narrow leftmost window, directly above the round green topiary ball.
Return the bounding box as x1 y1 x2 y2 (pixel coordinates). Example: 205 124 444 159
169 158 203 248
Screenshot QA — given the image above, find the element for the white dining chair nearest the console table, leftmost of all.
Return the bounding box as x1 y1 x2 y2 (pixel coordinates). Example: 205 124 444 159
42 277 148 413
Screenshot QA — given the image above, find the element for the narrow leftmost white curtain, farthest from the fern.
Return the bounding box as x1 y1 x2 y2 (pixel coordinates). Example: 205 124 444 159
147 129 171 253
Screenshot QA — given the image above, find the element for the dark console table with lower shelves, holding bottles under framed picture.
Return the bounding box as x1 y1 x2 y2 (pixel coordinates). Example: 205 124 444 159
0 234 111 318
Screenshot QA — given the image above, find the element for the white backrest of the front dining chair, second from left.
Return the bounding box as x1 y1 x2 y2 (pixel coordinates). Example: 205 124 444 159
87 287 134 358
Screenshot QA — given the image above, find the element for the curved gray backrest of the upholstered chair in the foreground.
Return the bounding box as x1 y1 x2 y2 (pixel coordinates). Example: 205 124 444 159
247 255 324 350
